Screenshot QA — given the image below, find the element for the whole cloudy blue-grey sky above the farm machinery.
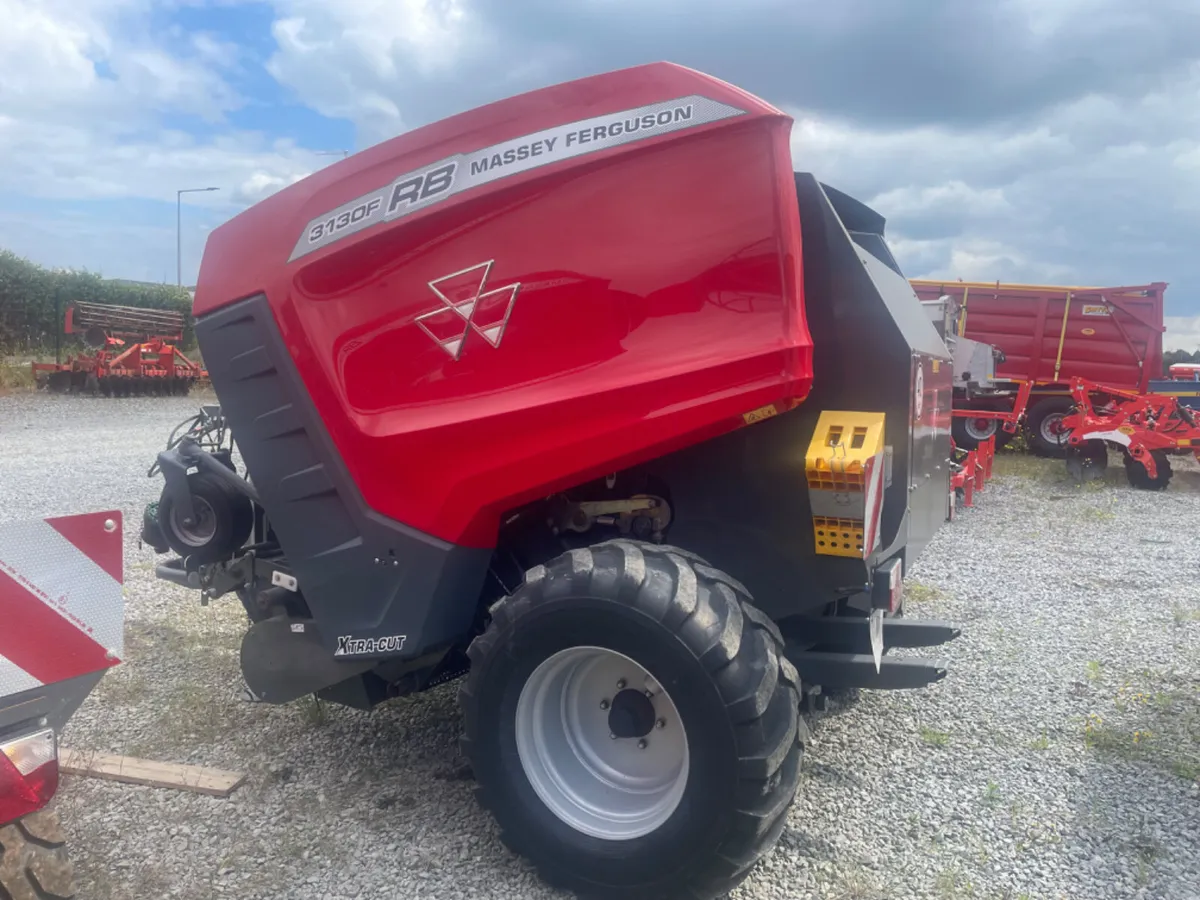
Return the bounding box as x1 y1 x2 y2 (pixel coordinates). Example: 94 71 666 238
0 0 1200 349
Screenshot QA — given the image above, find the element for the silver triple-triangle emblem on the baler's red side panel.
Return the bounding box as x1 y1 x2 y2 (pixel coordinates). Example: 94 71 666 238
416 259 521 360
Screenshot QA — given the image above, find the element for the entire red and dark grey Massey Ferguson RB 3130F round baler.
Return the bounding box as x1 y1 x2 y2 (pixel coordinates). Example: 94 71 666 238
144 64 958 898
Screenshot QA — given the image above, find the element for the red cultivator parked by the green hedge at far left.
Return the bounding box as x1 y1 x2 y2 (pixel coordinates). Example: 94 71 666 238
32 302 208 397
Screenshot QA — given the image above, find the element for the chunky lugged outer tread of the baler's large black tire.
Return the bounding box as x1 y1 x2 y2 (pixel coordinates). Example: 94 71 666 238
458 540 809 900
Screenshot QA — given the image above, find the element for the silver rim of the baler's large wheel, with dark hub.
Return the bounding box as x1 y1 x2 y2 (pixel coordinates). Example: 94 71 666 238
516 647 689 840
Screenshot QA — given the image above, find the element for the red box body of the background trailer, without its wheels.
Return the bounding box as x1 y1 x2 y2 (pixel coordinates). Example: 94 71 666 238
912 280 1166 391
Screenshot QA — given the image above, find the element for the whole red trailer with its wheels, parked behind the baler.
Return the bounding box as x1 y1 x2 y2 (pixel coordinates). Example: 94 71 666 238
911 278 1166 457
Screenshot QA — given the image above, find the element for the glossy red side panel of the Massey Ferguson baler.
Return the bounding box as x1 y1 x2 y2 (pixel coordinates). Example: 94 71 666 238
194 64 812 547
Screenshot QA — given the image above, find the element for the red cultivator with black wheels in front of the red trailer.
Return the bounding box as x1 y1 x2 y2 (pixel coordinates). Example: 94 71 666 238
1062 378 1200 491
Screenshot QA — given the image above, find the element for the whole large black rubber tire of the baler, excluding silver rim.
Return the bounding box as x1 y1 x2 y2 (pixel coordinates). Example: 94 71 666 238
458 540 808 900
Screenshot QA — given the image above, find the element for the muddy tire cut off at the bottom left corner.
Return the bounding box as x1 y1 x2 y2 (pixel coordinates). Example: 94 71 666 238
0 809 78 900
